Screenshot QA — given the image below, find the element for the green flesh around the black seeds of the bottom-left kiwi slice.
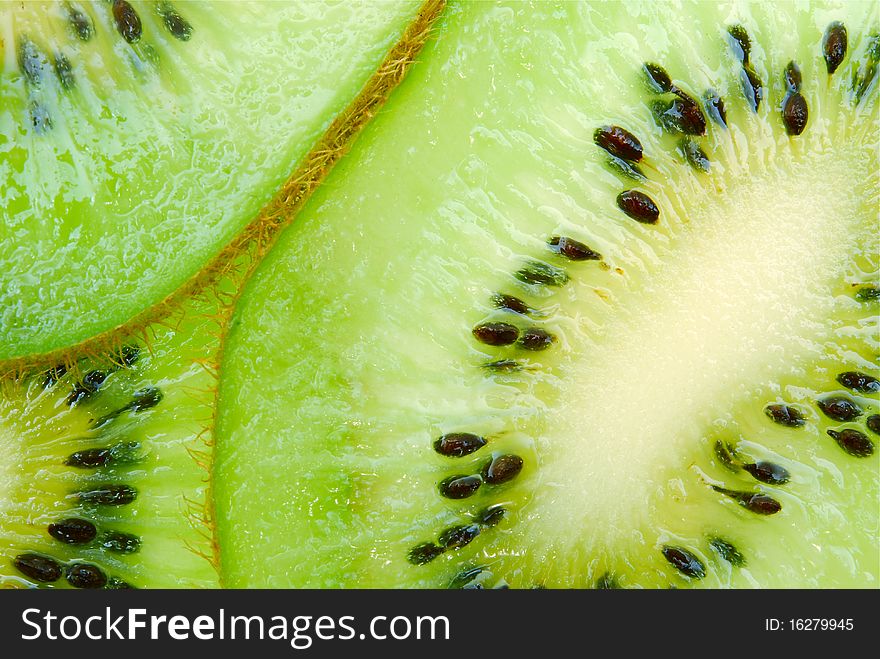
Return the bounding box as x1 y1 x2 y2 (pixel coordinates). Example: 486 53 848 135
0 292 218 588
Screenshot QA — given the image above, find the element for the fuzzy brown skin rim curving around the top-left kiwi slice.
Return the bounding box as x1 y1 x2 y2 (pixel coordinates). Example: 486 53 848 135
0 0 446 384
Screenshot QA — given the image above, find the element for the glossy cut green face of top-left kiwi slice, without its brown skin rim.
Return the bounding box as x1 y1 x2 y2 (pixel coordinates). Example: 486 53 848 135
0 1 417 359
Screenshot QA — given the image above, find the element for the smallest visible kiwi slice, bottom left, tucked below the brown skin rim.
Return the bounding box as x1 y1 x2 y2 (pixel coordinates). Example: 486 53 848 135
0 297 222 588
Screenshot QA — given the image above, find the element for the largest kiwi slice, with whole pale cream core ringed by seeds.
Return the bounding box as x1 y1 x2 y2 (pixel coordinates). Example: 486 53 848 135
214 2 880 588
